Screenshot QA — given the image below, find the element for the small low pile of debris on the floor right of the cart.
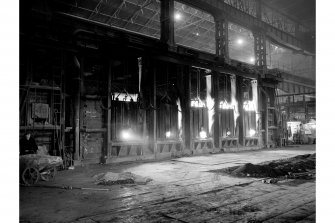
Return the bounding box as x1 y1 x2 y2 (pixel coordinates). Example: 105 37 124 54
93 172 152 185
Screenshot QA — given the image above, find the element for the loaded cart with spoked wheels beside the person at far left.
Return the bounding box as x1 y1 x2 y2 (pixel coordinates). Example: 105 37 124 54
20 154 63 185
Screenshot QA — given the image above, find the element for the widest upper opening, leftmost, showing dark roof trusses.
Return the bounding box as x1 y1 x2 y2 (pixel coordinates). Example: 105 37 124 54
61 0 161 39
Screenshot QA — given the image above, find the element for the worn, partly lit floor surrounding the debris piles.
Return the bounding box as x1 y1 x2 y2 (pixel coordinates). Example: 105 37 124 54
20 145 315 223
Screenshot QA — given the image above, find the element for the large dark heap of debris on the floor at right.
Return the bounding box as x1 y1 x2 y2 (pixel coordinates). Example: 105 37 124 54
212 153 316 179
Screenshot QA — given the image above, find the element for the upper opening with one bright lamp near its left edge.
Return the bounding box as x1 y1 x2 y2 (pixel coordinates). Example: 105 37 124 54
174 2 215 54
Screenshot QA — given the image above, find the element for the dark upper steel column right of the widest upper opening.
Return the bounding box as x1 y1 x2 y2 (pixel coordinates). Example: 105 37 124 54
160 0 174 46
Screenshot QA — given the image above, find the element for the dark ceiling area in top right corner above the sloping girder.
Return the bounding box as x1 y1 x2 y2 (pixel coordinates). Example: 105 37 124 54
263 0 316 31
